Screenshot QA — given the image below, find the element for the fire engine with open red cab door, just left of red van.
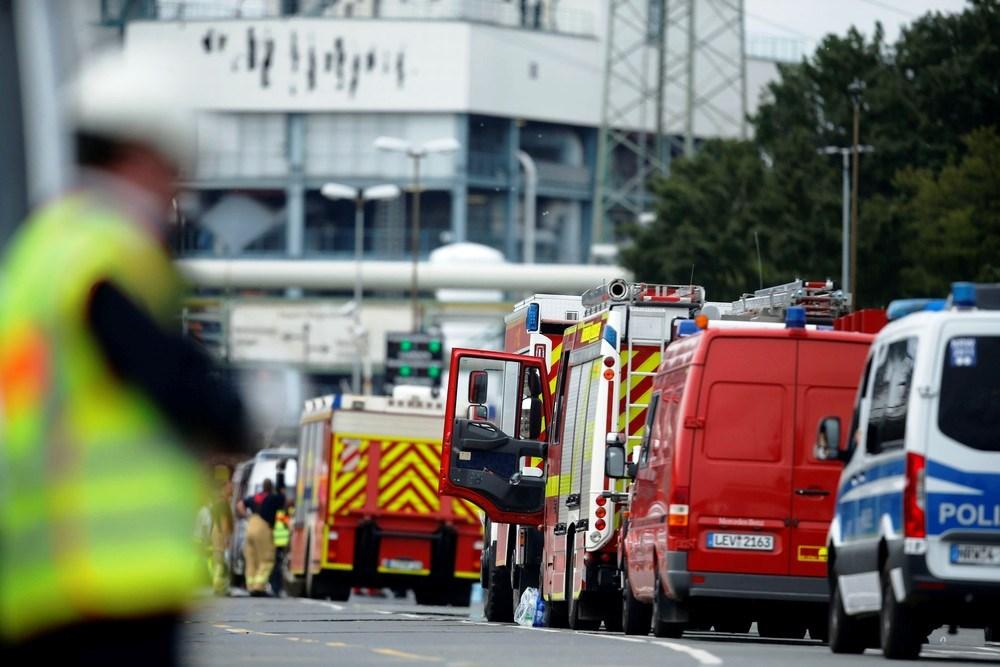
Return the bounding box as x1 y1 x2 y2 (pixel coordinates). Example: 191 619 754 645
439 280 704 629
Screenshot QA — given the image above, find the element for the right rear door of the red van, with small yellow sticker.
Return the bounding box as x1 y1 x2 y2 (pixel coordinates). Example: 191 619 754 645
789 340 868 577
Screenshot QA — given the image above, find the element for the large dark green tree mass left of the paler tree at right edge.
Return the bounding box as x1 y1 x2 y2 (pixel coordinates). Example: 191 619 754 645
622 0 1000 306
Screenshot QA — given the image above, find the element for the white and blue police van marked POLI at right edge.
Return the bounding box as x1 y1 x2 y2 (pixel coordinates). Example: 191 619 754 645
816 283 1000 658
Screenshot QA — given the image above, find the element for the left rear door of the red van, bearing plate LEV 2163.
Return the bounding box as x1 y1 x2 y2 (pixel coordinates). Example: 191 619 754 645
683 334 795 575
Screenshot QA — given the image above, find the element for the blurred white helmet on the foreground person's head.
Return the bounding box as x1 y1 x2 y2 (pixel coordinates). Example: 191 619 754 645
69 51 196 169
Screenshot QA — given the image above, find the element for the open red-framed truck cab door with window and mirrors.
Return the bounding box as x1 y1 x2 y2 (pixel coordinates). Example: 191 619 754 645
438 349 550 525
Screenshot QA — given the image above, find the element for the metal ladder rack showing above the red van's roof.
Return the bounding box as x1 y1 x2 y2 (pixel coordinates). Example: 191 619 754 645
728 280 850 324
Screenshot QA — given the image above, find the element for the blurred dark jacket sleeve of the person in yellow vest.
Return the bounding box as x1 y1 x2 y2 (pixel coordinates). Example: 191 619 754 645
87 282 249 452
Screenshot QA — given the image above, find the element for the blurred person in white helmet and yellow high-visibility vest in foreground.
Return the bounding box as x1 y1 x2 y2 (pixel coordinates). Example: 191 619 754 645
0 55 246 667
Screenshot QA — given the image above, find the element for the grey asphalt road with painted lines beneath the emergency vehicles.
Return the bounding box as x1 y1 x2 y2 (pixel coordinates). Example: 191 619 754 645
182 596 1000 667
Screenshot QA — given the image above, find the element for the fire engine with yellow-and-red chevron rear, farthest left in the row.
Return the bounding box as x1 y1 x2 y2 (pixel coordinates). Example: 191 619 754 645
285 387 482 606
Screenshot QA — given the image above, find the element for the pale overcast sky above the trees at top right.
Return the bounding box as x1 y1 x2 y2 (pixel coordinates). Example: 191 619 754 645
744 0 966 51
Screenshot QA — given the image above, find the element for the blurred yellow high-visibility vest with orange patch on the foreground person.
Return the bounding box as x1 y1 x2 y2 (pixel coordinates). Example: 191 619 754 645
0 194 203 640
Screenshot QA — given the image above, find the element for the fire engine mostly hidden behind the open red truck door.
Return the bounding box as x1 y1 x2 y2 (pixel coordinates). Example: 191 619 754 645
481 294 583 622
